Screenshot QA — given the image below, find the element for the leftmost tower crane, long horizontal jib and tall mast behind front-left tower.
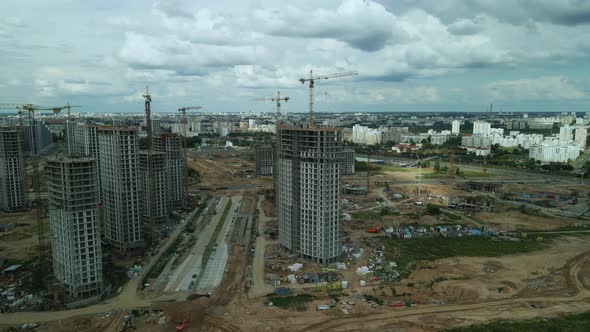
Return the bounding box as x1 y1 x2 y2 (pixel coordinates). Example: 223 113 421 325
0 104 71 281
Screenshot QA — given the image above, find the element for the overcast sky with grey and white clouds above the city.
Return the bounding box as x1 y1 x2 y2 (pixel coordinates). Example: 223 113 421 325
0 0 590 112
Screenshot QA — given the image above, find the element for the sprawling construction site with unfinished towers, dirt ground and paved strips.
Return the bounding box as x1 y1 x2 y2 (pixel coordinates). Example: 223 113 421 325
0 80 590 331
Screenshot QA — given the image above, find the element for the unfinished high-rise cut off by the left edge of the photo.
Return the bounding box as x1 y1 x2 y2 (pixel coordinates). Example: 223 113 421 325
0 128 26 211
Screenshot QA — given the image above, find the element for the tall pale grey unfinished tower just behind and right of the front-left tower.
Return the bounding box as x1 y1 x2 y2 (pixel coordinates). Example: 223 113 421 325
97 127 143 253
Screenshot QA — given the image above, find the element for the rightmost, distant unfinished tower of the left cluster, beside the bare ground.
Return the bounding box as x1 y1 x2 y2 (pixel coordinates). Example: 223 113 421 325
153 133 185 205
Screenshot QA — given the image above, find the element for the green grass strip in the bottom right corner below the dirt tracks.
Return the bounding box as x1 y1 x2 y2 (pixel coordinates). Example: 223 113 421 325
447 312 590 332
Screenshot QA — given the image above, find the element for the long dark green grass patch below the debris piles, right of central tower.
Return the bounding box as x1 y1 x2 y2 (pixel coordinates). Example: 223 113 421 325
382 236 551 277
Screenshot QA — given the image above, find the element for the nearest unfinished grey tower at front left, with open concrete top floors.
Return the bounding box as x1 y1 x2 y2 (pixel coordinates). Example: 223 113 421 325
45 157 103 298
